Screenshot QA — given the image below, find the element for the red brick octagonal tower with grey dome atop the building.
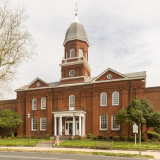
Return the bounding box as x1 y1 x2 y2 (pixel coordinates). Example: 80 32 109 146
60 13 91 85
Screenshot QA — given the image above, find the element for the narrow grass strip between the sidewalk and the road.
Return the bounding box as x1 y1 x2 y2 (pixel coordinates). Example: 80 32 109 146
0 148 154 158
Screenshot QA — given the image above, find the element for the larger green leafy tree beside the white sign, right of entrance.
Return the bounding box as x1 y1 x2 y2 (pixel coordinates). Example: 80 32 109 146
115 98 156 136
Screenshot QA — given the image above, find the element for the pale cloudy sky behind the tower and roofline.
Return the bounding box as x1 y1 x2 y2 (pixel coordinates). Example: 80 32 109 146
7 0 160 99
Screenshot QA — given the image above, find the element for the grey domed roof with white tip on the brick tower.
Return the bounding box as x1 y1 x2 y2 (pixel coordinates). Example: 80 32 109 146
63 15 89 46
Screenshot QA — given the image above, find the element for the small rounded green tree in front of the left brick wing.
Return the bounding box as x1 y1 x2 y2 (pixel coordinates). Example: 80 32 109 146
0 109 23 136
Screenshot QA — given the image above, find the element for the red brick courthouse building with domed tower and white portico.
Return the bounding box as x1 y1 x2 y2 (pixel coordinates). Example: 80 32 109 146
1 15 160 136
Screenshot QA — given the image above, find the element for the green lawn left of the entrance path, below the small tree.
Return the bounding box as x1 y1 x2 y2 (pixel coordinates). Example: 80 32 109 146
0 139 48 146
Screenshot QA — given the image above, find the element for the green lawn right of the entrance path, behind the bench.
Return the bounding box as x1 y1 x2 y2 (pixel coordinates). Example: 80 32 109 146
59 140 160 150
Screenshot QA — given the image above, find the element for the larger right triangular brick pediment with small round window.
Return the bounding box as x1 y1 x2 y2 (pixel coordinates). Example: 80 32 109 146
93 68 128 81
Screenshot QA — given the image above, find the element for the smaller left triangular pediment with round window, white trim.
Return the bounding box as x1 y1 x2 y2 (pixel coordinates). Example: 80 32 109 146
27 78 49 89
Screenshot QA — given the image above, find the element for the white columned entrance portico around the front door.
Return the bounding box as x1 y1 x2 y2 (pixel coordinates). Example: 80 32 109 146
52 110 86 136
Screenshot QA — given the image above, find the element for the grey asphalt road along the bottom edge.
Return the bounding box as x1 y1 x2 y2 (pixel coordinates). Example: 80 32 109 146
0 152 152 160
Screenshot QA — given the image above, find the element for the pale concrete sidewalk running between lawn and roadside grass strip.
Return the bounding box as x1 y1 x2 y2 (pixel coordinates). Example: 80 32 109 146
0 147 160 160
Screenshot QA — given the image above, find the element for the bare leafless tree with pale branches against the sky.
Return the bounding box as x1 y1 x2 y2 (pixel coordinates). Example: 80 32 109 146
0 0 35 96
